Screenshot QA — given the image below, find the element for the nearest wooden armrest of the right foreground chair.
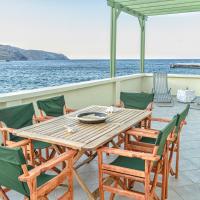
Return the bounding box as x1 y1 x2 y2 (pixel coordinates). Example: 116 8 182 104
98 147 160 161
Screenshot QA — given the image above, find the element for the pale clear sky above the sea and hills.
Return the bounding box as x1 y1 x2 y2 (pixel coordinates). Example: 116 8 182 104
0 0 200 59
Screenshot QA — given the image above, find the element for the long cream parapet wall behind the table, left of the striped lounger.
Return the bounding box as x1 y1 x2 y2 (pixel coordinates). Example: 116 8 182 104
0 74 143 113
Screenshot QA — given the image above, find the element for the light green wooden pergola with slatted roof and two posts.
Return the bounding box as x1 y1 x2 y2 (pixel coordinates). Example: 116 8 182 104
107 0 200 77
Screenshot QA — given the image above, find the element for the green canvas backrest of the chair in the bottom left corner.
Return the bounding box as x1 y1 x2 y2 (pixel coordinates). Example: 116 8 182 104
0 147 29 196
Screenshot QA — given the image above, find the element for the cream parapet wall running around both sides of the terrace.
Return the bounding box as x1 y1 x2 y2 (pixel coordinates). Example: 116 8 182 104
0 74 200 110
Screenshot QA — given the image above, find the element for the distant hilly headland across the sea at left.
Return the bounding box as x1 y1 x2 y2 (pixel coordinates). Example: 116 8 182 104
0 45 68 61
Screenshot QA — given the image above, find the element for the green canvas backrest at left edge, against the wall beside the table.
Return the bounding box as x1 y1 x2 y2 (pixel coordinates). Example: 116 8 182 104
0 103 35 140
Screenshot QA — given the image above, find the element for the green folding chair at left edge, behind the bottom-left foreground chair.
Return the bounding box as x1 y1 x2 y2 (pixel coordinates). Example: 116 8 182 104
0 103 52 166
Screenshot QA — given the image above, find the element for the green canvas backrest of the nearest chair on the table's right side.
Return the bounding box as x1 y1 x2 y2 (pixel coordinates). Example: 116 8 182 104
156 115 178 156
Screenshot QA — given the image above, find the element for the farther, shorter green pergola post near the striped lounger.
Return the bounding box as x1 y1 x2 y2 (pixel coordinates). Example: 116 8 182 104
138 16 146 73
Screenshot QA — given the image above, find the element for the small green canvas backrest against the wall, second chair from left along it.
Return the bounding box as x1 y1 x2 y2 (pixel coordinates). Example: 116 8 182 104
37 95 65 117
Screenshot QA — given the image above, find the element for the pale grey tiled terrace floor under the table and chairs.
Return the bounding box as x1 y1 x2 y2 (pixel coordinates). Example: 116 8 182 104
5 103 200 200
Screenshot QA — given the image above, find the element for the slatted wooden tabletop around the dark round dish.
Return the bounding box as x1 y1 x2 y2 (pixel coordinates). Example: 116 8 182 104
11 106 151 149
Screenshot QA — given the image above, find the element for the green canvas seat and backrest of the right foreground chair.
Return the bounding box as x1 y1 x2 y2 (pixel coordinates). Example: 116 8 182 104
111 115 178 171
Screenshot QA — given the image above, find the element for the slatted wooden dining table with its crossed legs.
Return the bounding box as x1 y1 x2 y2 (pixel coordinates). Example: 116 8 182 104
12 105 151 199
